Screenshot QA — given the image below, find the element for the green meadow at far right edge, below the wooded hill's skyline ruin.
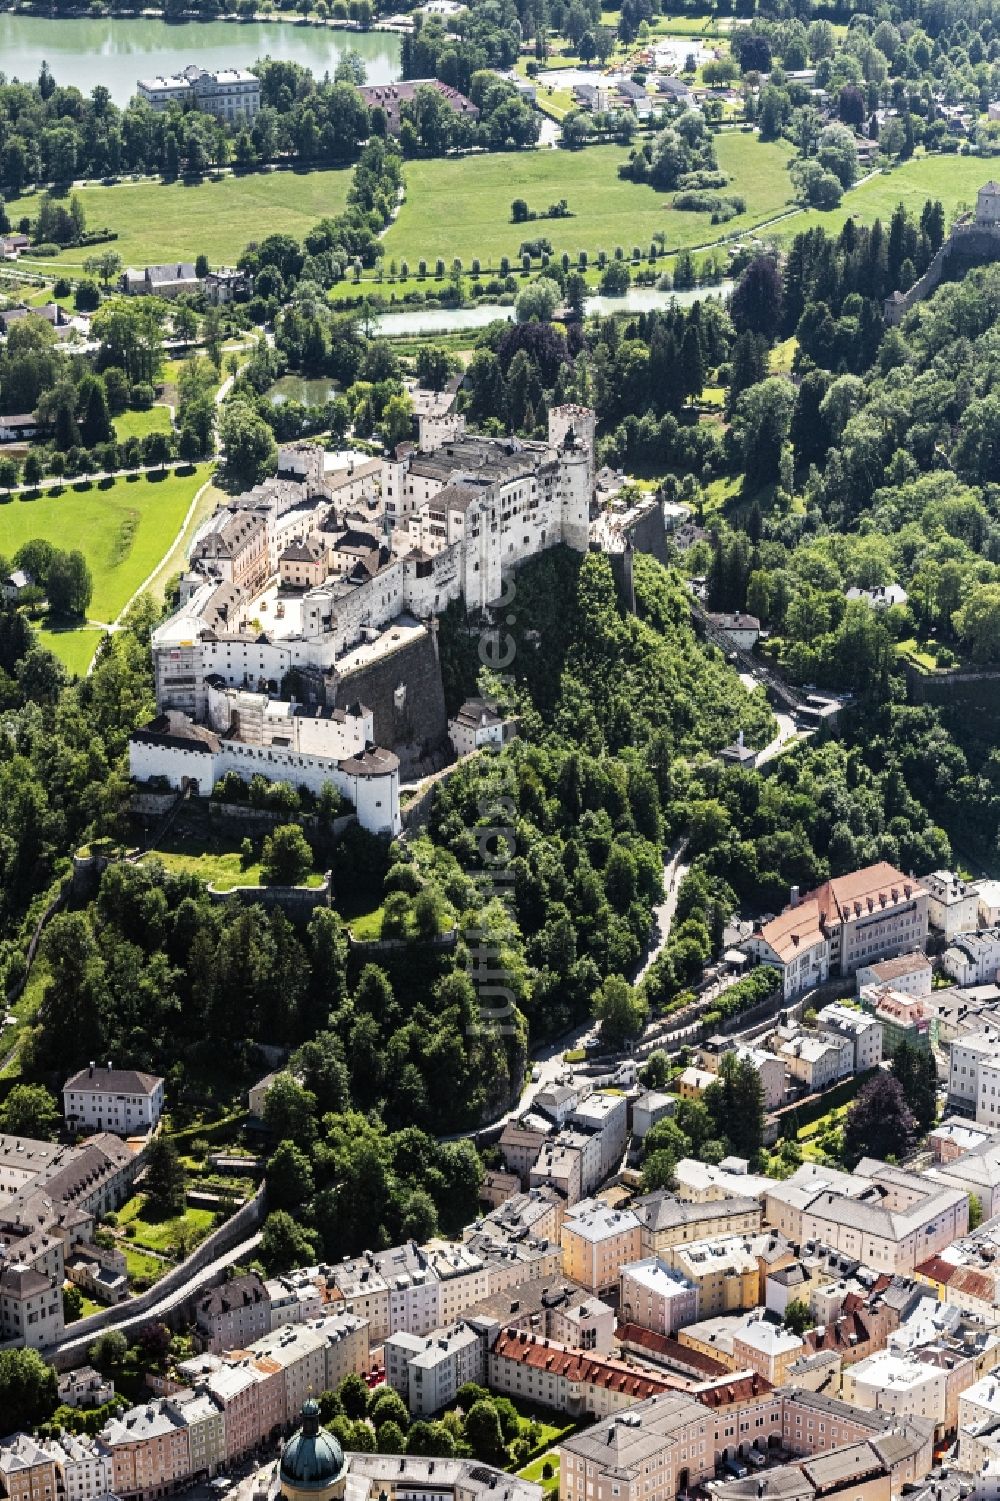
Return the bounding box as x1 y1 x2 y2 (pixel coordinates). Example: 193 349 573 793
765 156 991 240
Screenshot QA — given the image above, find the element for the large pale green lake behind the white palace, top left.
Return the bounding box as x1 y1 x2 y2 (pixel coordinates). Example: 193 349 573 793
0 14 401 105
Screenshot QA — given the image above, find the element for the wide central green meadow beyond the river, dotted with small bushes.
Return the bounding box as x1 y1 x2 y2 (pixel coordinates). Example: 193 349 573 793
384 131 791 275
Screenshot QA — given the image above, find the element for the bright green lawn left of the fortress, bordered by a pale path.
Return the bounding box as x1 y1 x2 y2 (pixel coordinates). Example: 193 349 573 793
0 464 209 621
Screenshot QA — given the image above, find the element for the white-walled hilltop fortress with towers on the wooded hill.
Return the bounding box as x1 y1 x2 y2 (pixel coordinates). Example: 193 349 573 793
131 405 595 833
